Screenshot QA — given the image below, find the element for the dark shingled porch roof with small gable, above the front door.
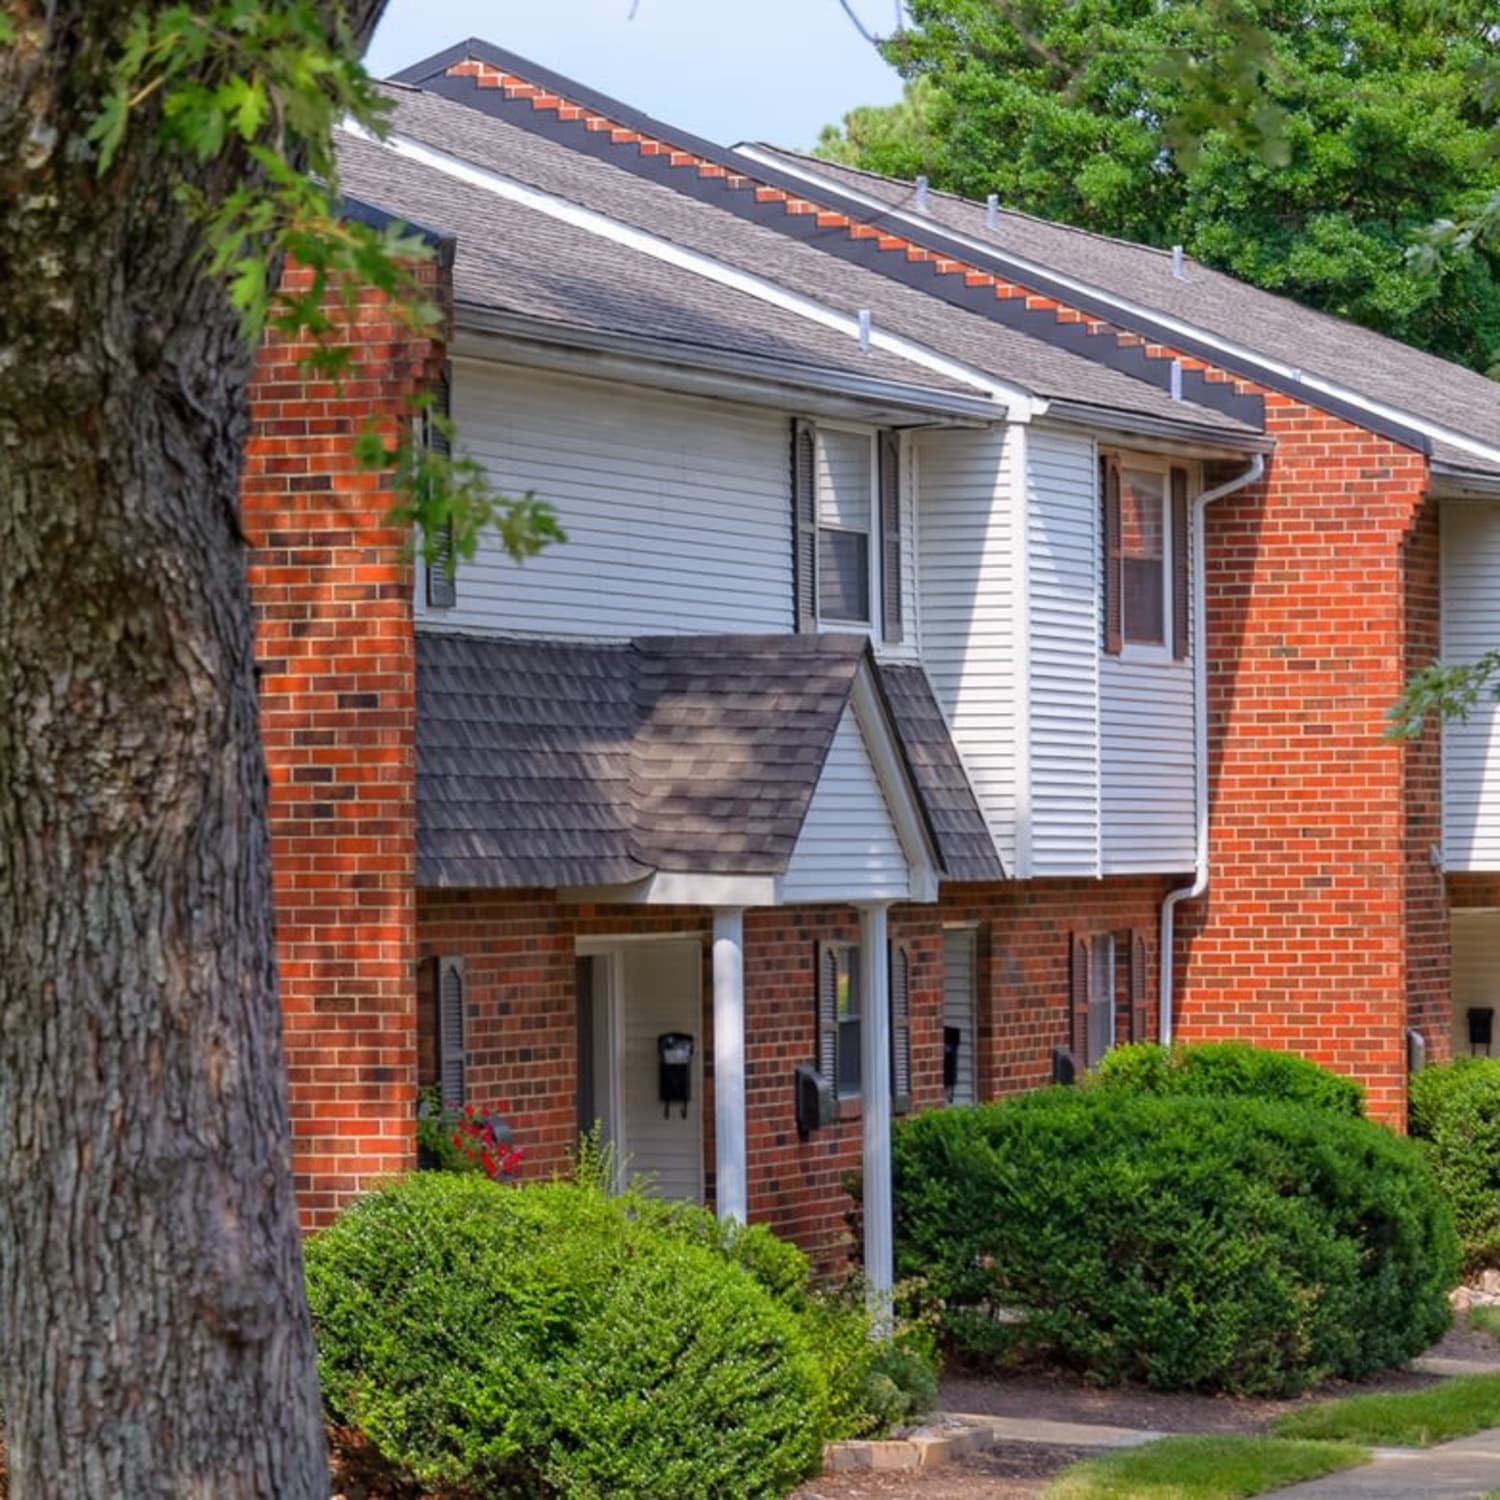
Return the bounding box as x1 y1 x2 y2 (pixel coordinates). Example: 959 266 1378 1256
417 632 1001 888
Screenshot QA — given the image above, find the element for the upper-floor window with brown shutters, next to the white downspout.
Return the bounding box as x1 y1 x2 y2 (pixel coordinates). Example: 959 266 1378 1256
1100 453 1191 660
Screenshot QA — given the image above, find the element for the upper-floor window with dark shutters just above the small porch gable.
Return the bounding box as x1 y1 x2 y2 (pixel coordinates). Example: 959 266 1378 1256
792 422 902 642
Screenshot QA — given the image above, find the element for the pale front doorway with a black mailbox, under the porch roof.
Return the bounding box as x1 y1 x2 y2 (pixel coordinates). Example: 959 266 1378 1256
581 938 704 1203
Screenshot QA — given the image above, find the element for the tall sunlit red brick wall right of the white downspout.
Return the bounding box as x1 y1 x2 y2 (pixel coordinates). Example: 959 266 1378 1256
1178 395 1428 1125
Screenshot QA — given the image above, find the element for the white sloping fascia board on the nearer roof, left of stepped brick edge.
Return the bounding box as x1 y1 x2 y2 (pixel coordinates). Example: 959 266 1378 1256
342 122 1046 419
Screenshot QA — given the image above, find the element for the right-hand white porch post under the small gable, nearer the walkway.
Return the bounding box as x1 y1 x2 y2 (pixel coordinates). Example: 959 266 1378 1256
860 906 894 1326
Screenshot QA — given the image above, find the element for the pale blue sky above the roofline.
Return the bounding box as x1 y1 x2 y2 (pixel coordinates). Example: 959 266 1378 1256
366 0 902 149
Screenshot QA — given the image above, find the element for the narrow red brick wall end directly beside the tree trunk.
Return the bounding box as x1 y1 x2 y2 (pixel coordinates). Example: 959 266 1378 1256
243 270 438 1227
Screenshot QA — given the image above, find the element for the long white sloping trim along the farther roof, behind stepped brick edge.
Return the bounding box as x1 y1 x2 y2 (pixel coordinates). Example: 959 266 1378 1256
734 146 1500 474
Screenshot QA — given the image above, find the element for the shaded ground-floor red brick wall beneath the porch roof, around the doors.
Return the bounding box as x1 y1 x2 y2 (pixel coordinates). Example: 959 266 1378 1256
417 879 1164 1271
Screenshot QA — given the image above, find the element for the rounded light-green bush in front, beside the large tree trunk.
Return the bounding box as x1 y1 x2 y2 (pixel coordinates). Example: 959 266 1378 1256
308 1173 828 1497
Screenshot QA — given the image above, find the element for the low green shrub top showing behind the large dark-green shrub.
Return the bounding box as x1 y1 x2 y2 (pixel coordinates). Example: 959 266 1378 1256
1089 1041 1365 1115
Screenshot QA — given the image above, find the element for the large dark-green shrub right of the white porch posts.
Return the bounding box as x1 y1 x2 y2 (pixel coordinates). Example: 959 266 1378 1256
894 1088 1457 1392
